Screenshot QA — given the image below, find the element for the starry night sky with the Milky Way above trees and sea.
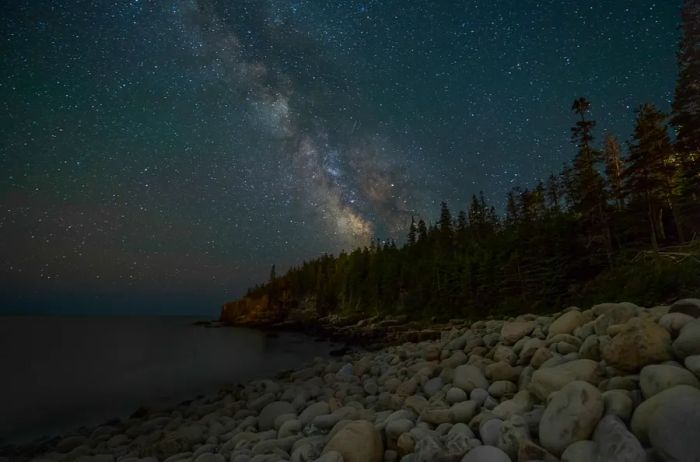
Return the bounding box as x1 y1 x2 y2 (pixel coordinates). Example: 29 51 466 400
0 0 680 313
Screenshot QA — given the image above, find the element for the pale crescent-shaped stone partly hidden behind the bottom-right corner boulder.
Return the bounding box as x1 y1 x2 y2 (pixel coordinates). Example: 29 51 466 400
630 385 700 444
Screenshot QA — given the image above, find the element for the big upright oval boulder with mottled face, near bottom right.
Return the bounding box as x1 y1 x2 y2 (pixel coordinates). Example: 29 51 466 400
539 381 604 455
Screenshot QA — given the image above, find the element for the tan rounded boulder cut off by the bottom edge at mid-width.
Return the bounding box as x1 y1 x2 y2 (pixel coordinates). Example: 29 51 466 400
323 420 384 462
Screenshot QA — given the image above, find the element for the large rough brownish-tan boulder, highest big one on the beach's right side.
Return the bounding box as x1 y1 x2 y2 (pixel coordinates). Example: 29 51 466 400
602 318 672 371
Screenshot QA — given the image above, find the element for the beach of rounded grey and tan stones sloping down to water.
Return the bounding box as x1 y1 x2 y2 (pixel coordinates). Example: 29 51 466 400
5 299 700 462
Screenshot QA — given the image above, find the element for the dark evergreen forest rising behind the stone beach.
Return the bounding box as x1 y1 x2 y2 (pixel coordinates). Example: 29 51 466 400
242 0 700 318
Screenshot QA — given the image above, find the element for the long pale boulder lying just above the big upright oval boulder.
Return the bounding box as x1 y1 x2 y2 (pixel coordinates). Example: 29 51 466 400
528 359 601 400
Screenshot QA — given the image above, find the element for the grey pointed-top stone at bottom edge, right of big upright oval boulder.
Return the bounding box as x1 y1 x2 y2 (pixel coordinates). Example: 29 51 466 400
593 415 646 462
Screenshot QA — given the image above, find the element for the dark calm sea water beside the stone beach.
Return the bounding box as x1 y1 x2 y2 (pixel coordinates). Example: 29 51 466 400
0 316 333 443
